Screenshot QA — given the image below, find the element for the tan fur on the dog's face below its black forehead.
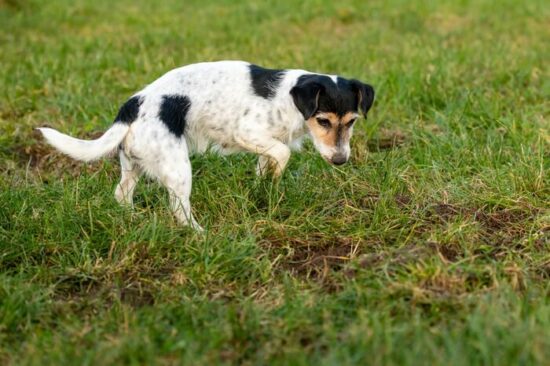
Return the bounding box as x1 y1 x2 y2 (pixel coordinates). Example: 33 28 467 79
306 112 358 149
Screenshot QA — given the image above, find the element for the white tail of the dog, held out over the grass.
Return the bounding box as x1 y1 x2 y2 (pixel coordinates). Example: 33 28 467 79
38 123 130 161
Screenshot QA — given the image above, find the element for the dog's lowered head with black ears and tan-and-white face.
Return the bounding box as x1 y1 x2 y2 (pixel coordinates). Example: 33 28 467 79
290 74 374 165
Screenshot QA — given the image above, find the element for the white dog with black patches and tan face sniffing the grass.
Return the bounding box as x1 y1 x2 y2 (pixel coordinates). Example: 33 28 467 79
39 61 374 231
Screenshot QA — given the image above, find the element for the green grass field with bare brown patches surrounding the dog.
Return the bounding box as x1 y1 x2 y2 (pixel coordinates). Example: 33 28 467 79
0 0 550 365
